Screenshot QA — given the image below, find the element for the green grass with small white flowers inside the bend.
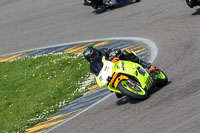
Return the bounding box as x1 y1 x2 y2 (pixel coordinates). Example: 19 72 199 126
0 54 94 133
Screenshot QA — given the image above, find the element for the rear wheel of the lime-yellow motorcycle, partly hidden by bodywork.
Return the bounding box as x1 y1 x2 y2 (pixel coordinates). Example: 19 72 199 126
156 70 168 87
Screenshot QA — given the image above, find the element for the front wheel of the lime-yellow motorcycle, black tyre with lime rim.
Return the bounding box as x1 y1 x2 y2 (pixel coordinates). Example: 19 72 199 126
117 80 149 100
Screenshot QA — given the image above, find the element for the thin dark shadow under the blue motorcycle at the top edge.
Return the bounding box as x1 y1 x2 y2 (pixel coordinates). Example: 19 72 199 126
92 0 141 14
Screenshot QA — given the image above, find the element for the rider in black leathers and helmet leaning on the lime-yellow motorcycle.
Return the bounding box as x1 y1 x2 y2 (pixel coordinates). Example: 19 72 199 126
83 46 161 98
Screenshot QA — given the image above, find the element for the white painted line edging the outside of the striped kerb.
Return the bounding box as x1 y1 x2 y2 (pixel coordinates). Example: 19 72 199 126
43 37 158 133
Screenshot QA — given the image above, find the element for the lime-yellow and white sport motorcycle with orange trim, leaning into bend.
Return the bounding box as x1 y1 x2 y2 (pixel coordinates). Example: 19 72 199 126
91 57 168 100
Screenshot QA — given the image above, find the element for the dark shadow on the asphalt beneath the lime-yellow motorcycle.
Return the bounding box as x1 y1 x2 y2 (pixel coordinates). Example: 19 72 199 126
116 81 172 106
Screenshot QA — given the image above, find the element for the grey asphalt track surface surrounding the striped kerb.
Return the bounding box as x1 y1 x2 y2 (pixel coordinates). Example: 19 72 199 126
0 0 200 133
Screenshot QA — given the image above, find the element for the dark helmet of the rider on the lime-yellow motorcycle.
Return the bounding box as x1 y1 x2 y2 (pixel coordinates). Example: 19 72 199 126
83 46 100 62
